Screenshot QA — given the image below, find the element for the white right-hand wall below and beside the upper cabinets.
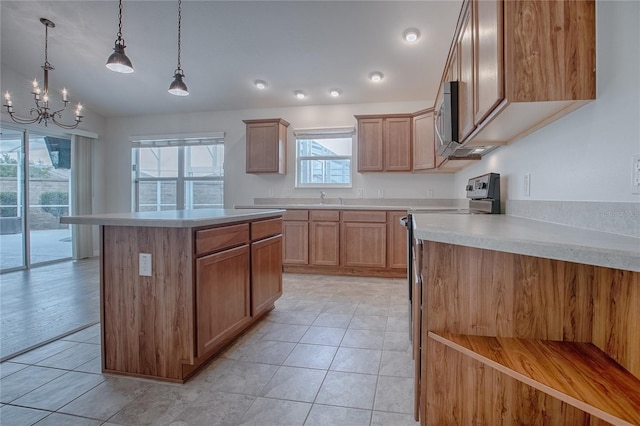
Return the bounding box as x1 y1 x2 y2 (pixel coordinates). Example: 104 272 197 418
454 1 640 202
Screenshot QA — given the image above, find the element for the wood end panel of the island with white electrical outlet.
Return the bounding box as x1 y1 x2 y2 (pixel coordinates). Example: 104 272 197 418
101 226 195 381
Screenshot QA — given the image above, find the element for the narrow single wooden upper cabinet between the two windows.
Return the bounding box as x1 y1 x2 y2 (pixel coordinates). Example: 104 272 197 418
243 118 289 175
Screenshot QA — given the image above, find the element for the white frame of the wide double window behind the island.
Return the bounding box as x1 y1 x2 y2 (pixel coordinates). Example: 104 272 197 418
131 133 225 212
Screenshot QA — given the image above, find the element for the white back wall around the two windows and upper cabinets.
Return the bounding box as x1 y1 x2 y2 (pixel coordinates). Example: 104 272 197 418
99 102 453 212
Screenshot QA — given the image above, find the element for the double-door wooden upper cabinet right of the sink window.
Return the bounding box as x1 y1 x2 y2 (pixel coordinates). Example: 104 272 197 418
355 114 412 173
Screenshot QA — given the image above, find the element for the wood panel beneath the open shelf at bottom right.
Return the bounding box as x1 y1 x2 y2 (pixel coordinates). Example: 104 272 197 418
421 339 591 426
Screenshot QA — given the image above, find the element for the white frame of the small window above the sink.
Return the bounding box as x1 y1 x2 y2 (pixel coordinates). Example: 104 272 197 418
293 127 355 189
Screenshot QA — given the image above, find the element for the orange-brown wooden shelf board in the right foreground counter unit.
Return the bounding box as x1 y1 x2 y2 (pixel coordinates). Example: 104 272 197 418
429 332 640 425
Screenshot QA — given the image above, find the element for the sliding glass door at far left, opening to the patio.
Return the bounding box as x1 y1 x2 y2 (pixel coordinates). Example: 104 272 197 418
0 128 71 271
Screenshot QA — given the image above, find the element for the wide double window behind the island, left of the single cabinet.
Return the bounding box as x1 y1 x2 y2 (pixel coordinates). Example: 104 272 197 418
132 134 224 211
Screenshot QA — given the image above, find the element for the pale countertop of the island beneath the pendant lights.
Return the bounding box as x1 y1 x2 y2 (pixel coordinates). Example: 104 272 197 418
60 209 285 228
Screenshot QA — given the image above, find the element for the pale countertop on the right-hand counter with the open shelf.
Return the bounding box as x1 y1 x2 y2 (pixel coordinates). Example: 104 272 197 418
413 213 640 272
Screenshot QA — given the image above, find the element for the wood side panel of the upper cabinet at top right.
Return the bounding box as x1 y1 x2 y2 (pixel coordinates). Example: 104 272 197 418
504 1 596 102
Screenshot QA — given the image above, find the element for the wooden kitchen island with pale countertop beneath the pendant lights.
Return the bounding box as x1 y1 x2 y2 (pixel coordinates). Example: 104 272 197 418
60 209 284 382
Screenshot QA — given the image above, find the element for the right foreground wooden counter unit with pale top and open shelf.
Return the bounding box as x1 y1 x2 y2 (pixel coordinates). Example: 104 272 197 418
412 214 640 425
